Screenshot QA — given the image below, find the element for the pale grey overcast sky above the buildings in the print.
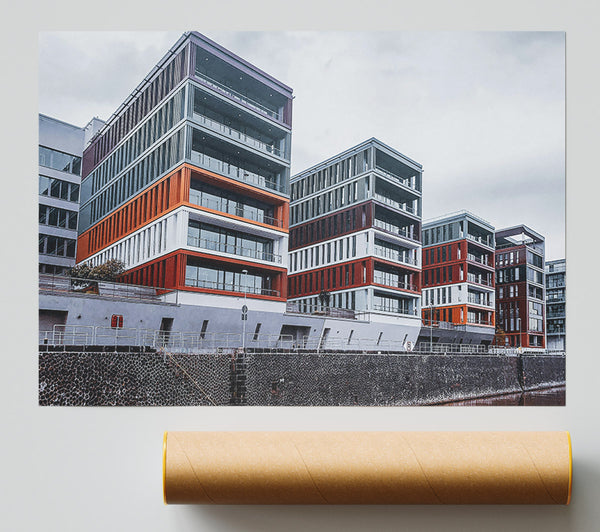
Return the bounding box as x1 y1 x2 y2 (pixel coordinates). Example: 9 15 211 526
39 28 565 260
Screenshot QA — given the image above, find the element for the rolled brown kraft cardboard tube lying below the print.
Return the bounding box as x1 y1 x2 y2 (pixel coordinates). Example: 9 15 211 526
163 432 572 504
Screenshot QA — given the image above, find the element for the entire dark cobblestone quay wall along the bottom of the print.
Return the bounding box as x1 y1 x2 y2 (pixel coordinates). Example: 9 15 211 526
39 352 565 406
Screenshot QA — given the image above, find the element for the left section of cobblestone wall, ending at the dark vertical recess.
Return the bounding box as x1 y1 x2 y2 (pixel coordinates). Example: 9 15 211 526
39 352 231 406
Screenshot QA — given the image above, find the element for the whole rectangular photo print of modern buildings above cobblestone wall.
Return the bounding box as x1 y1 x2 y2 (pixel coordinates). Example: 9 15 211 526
39 31 566 406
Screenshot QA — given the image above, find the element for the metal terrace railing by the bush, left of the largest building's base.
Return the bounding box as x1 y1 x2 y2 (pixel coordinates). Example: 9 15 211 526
39 273 177 304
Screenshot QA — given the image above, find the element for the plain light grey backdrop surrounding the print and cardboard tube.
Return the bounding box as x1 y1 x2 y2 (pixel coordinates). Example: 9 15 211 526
0 0 600 532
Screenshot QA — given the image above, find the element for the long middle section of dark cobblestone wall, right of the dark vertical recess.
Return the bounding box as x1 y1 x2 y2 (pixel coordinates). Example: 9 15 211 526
241 354 520 406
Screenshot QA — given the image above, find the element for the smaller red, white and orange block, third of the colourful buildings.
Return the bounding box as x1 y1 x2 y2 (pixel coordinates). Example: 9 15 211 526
422 211 495 345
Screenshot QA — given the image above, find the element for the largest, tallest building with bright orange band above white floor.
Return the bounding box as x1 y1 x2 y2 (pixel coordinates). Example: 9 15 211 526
77 32 292 304
